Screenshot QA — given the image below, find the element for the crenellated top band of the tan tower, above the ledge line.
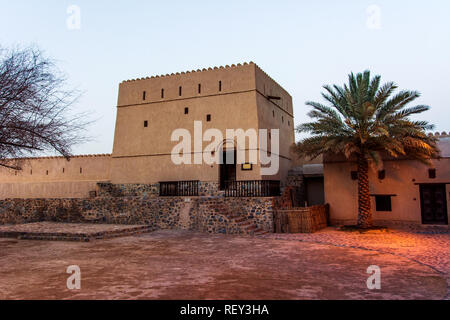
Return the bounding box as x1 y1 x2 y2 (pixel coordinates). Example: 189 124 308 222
117 62 292 114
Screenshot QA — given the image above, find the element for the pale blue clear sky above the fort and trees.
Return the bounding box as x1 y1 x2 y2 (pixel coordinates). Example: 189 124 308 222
0 0 450 154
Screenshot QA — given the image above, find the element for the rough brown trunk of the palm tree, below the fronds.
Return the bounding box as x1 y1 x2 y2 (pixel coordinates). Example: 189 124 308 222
358 156 373 229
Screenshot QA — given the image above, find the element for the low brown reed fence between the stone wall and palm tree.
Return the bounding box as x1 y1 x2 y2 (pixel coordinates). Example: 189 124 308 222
274 205 329 233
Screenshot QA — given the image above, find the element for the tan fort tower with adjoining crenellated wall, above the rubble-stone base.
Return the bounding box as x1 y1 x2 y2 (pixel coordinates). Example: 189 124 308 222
0 63 294 199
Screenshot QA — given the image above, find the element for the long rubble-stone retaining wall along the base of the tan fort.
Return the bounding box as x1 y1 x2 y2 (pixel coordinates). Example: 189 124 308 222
0 196 273 234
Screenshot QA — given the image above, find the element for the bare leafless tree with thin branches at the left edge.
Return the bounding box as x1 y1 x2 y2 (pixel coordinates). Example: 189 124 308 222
0 48 88 170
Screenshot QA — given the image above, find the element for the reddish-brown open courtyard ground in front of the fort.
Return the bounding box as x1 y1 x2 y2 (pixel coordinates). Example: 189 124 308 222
0 230 449 299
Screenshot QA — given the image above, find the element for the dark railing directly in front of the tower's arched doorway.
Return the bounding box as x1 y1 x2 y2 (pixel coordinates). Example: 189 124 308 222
225 180 281 197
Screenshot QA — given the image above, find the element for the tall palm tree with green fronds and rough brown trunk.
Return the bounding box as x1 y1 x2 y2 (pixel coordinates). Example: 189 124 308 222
295 71 439 228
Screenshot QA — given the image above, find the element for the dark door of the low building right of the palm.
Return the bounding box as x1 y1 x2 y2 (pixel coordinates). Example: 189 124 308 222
420 184 448 225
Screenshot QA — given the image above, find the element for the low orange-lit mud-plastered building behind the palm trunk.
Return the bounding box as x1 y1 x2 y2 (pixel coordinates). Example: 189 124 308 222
324 133 450 226
